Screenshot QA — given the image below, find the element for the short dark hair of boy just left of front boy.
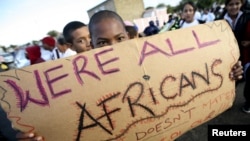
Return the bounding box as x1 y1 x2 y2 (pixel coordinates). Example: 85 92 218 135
63 21 87 43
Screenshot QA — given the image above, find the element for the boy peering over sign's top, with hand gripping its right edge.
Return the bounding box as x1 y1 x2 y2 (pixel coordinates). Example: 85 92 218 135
89 10 243 140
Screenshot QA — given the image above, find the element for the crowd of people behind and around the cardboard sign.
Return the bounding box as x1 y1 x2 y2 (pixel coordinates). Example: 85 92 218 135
0 0 250 141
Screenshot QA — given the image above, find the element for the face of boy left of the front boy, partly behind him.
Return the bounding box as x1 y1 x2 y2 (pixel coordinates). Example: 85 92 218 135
71 26 91 53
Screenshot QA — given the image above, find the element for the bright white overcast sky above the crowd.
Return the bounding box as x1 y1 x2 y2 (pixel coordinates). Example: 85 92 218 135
0 0 180 46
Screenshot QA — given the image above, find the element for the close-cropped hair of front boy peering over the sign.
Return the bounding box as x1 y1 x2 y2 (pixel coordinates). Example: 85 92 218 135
89 10 126 36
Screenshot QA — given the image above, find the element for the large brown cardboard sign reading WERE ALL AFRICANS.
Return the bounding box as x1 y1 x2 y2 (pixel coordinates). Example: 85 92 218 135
0 21 239 141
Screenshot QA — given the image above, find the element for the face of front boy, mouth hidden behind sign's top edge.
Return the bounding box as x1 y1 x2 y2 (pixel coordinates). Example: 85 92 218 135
91 18 129 48
